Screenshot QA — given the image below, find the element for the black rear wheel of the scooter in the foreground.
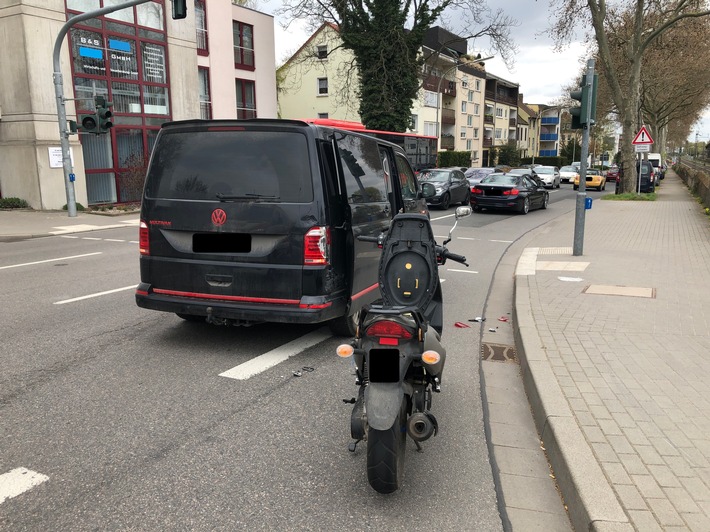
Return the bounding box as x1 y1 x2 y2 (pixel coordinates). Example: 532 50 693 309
367 397 407 493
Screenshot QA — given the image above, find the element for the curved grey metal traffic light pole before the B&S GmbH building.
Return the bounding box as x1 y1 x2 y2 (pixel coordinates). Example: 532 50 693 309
52 0 150 217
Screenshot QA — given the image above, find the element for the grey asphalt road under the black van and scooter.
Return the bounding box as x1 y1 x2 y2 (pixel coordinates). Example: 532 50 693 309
0 185 597 531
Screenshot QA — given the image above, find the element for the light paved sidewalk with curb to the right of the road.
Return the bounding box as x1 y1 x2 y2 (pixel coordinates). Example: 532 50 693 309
515 172 710 532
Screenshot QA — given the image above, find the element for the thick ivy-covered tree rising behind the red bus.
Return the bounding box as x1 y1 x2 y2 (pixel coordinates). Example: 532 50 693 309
279 0 514 132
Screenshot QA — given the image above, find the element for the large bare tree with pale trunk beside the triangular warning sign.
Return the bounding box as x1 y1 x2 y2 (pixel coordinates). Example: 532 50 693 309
551 0 710 191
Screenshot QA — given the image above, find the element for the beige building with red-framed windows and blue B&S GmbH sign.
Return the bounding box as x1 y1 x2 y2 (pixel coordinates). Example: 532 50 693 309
0 0 276 209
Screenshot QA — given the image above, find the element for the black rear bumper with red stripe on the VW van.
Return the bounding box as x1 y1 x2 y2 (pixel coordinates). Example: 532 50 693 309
136 283 348 323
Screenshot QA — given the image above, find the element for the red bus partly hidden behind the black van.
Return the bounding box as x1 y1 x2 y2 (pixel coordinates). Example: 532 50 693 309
304 118 437 172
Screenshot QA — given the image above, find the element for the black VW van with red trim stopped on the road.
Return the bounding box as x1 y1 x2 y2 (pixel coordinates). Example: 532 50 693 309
136 119 427 335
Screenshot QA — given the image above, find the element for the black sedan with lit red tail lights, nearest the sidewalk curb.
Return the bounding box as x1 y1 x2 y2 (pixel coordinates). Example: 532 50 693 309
471 173 550 214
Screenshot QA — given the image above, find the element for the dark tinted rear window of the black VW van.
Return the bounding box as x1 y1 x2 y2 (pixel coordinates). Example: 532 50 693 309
146 130 313 203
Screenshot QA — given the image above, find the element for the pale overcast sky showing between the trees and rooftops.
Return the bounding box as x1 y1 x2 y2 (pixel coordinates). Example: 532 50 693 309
257 0 710 142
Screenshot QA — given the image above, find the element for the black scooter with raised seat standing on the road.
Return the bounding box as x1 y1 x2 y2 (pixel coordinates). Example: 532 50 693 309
337 207 471 493
